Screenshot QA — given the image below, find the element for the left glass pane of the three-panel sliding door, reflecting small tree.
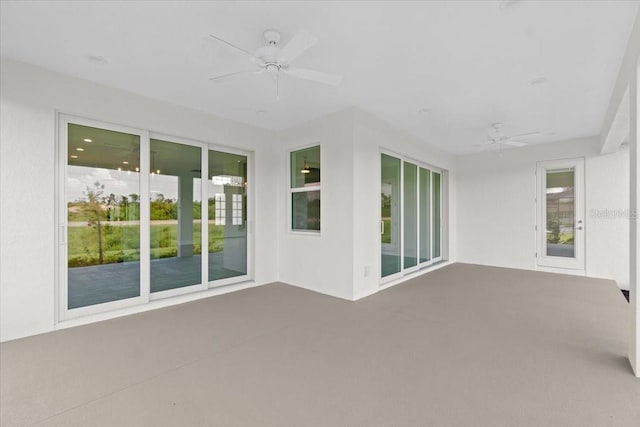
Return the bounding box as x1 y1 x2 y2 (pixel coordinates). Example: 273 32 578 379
65 123 140 310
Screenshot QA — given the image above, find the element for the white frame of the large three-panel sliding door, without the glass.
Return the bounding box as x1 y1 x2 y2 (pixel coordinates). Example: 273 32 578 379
54 112 255 323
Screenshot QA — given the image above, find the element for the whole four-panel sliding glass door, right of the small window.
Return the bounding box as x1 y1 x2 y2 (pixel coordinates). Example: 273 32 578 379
380 153 442 281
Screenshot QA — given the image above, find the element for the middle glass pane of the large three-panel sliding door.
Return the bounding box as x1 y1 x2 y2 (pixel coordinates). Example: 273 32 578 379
149 139 202 292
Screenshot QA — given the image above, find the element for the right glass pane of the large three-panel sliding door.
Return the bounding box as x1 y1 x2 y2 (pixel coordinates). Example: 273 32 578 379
207 150 247 281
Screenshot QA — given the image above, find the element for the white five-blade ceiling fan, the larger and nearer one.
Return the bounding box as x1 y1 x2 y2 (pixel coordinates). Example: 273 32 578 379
209 30 342 100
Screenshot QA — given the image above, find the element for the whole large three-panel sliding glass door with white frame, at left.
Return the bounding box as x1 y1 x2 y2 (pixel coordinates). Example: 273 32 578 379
58 115 251 320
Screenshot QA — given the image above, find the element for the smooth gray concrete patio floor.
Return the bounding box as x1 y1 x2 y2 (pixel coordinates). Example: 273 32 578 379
0 264 640 427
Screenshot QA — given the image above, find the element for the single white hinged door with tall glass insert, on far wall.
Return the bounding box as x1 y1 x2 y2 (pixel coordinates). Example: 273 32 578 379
536 158 585 270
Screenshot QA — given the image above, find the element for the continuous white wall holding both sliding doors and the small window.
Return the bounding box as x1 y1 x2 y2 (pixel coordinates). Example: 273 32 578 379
0 59 456 341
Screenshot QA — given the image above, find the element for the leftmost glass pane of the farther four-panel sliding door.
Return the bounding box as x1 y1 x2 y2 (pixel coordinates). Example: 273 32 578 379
380 154 401 277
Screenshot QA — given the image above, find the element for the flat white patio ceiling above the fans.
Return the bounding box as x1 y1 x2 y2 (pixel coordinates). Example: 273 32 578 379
0 0 638 153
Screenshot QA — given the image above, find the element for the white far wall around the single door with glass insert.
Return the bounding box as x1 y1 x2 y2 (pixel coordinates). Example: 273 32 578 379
456 137 629 288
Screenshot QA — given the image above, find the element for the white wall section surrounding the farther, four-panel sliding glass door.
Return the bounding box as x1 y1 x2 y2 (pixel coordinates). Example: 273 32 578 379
351 110 456 299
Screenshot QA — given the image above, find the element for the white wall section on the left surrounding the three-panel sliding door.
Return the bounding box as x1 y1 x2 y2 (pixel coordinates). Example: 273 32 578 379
0 58 279 341
